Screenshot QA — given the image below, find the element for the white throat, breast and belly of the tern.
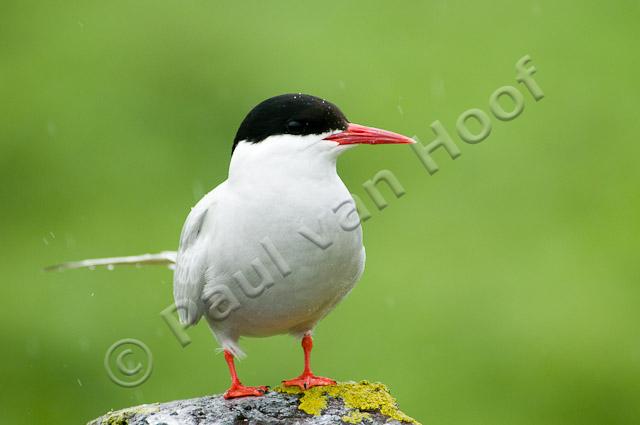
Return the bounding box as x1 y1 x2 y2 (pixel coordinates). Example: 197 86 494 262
203 136 365 340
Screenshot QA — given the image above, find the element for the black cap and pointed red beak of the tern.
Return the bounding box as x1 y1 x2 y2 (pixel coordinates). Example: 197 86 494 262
232 93 415 152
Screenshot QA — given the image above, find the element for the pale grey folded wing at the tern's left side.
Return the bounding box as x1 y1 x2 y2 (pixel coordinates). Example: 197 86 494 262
173 186 220 325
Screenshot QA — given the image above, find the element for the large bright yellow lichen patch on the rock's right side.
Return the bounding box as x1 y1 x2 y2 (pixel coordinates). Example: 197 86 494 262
274 381 419 425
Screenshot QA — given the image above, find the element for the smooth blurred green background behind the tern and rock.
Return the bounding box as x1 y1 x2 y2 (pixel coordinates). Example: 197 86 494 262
0 0 640 425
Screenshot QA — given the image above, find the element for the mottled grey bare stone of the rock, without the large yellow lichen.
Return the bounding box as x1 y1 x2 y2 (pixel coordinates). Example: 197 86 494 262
89 383 420 425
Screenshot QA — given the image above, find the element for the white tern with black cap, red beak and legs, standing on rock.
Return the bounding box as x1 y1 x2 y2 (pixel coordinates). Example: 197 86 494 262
46 93 415 399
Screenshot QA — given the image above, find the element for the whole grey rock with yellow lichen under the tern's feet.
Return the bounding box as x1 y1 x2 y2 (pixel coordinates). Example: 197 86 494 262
88 381 419 425
